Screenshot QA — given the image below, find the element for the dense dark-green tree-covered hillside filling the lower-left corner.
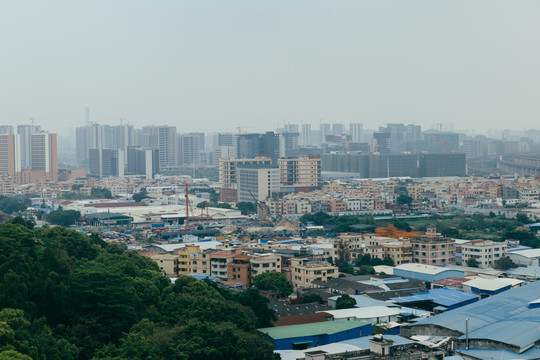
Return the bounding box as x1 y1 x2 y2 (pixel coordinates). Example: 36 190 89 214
0 223 275 360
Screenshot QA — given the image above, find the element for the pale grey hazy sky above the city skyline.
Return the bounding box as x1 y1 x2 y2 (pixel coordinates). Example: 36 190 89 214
0 0 540 132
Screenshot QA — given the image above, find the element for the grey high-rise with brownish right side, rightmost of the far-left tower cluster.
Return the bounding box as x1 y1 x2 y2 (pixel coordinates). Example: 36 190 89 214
30 133 58 181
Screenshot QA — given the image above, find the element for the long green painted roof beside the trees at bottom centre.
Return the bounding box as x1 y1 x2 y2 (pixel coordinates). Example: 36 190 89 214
257 320 370 340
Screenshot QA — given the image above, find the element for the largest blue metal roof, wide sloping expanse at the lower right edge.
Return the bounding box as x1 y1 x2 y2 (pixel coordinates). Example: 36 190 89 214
411 281 540 355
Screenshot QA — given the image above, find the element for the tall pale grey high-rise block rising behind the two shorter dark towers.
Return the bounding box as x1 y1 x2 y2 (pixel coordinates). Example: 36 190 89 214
143 125 177 170
